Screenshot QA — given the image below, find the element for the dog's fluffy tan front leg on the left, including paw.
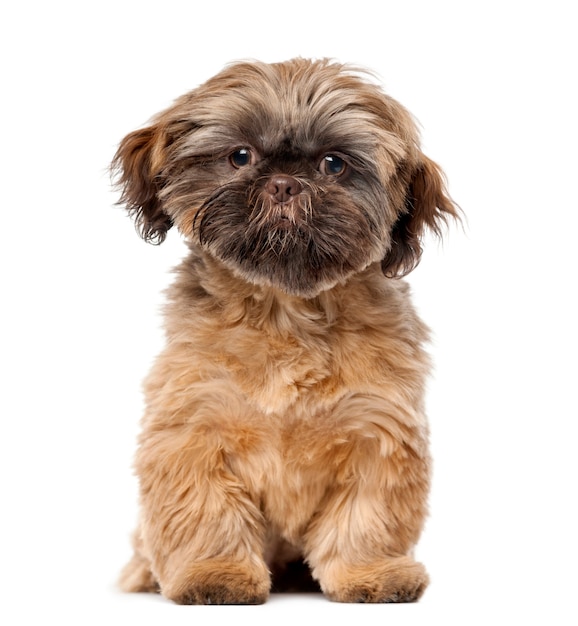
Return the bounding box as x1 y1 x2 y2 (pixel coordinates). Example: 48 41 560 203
136 424 270 604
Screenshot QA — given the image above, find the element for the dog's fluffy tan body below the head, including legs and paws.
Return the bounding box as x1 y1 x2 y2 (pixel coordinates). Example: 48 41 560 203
111 59 451 603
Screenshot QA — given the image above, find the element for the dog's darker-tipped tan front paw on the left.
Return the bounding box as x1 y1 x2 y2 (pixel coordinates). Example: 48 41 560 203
162 559 271 604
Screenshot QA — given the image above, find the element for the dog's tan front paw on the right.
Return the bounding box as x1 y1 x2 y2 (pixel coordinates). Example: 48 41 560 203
321 557 429 603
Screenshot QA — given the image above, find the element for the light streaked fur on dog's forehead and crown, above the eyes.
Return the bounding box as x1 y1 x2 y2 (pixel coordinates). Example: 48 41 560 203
164 59 418 173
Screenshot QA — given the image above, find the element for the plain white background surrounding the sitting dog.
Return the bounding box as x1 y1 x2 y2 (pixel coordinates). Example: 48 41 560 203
0 0 578 625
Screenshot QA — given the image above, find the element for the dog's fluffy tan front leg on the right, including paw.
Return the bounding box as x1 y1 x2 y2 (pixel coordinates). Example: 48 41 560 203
305 412 429 602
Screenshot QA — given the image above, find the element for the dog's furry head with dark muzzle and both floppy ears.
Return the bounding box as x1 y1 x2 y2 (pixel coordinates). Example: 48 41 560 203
113 59 457 297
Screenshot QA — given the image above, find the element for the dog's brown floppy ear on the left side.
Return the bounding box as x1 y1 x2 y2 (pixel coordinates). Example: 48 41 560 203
111 123 173 244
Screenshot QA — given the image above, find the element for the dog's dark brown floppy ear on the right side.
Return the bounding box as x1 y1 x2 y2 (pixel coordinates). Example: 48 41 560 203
381 155 459 277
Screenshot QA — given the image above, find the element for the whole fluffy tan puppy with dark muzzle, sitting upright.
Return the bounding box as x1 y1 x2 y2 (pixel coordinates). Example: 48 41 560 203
112 58 459 604
